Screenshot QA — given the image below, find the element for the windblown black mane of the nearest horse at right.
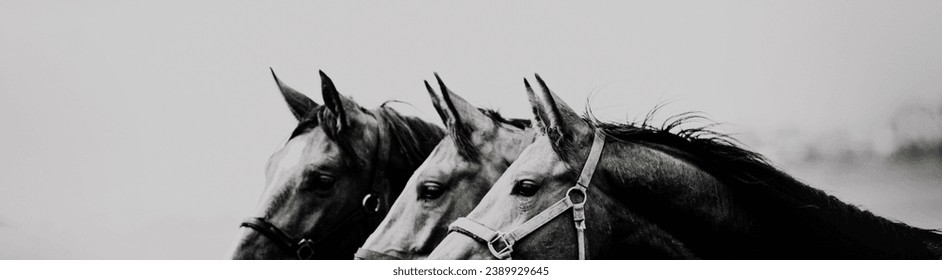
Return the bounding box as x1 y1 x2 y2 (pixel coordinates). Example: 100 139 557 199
588 107 942 258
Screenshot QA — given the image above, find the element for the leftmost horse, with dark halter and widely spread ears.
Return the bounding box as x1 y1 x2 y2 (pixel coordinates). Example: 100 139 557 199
233 70 444 259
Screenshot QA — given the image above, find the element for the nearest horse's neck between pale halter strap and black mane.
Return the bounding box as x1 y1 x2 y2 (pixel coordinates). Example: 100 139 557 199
590 141 746 258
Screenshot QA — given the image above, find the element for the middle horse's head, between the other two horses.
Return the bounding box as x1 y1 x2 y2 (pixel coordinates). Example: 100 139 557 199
356 74 536 259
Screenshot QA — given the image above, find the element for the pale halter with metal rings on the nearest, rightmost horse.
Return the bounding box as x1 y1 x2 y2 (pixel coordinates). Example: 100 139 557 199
448 132 605 260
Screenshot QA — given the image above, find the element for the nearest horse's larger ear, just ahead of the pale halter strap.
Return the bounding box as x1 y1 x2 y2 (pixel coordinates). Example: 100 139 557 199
535 74 589 144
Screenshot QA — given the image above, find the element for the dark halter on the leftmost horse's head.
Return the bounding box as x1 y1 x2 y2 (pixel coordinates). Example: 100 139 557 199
239 114 390 260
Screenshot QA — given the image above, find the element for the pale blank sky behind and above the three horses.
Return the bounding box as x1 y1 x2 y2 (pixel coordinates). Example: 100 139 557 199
0 0 942 259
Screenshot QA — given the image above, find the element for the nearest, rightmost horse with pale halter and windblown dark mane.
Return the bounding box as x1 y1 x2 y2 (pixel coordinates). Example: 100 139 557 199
429 75 942 259
